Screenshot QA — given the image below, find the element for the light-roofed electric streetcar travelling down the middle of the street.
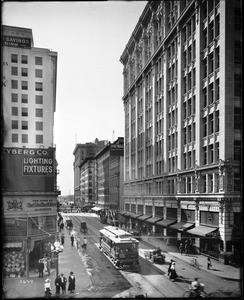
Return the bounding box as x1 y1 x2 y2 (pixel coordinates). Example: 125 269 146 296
99 226 140 272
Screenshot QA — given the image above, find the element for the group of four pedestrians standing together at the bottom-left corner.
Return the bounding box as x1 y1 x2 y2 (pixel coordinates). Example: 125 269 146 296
44 271 75 298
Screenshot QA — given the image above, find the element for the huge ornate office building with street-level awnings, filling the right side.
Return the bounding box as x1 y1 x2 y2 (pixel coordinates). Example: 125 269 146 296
120 0 242 261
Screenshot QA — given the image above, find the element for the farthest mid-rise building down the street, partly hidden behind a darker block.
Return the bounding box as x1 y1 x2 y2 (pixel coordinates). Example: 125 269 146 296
73 139 108 207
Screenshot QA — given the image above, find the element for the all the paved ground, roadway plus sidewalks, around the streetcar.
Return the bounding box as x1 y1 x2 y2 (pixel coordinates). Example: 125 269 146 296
4 214 240 299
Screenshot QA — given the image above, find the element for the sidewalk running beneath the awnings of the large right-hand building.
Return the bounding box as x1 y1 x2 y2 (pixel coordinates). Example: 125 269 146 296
142 236 242 281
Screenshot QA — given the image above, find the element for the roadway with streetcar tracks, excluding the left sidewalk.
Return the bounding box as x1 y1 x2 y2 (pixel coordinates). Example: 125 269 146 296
60 213 239 298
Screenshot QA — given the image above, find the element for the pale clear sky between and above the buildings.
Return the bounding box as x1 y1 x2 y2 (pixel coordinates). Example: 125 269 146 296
2 1 147 196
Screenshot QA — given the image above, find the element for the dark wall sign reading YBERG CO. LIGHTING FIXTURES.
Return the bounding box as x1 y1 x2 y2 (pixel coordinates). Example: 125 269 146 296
2 148 55 192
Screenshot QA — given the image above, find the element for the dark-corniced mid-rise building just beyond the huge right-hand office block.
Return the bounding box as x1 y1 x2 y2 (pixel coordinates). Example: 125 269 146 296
95 137 124 214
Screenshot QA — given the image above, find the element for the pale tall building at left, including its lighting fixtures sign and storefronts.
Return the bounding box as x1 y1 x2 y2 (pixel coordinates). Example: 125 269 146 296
1 25 60 277
